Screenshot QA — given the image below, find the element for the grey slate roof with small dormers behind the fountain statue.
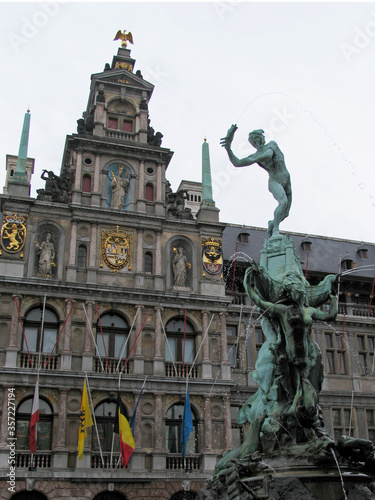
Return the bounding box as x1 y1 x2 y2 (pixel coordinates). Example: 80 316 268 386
223 225 375 279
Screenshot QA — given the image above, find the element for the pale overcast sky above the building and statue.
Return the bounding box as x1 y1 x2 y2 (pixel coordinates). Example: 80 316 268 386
0 1 375 242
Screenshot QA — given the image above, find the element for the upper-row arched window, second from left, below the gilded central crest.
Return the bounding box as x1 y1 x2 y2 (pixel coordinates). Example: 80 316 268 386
96 313 129 359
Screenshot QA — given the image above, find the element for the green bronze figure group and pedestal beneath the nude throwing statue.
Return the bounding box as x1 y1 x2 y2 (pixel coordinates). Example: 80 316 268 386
215 235 337 475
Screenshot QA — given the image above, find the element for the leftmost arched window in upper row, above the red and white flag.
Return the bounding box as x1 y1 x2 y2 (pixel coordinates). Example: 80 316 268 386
22 306 59 353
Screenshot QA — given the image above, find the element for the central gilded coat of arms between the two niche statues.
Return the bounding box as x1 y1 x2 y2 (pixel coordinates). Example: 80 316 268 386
100 226 133 272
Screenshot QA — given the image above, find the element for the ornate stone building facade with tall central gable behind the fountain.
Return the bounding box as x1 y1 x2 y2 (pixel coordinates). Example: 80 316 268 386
0 43 375 500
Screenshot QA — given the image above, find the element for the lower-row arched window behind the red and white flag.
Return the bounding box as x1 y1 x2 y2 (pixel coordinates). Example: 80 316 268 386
16 397 53 451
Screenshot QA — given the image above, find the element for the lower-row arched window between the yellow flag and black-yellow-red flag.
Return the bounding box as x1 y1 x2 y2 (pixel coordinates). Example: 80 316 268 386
92 400 130 454
